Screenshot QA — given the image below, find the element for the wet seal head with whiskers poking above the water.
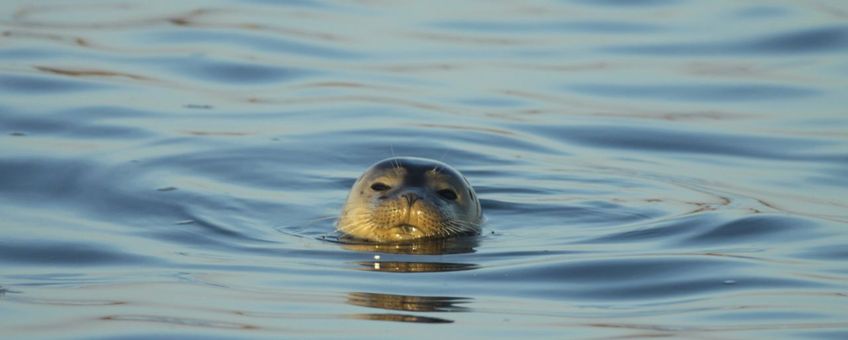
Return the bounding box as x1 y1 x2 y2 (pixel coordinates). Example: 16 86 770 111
337 157 483 243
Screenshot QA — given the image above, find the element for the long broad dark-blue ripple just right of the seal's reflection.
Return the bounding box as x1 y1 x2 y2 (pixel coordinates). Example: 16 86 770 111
465 256 827 301
